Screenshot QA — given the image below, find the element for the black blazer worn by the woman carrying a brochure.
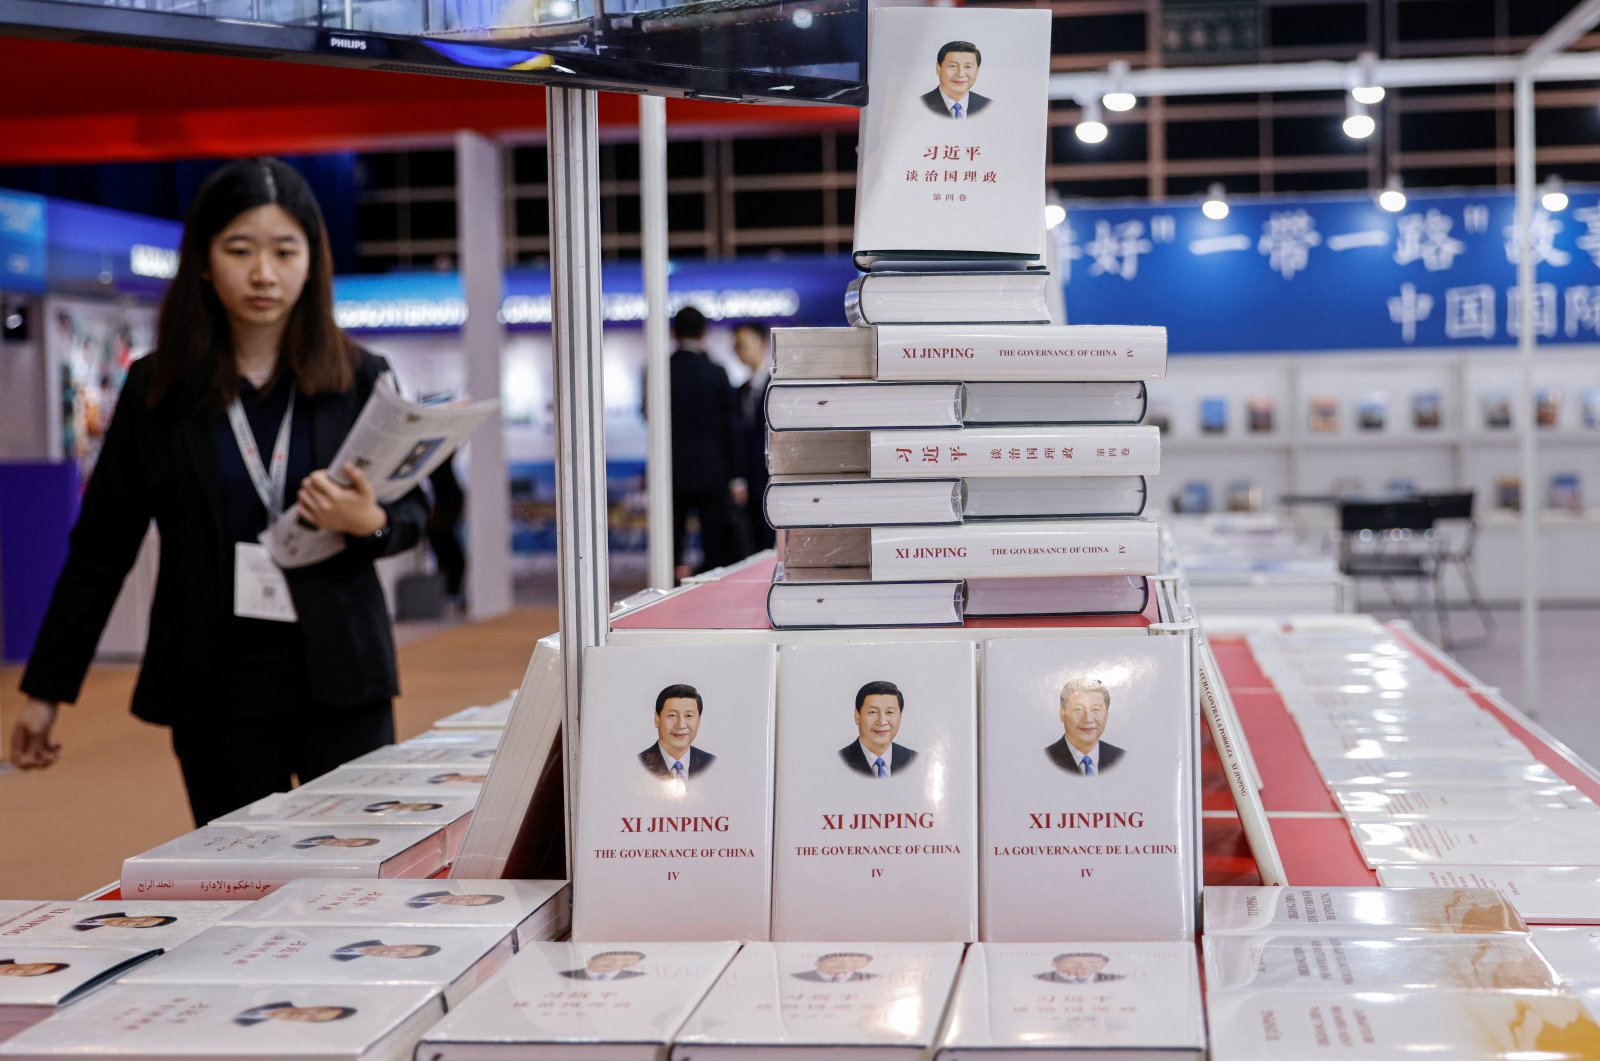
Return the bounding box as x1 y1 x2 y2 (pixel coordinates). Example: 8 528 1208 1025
22 352 427 725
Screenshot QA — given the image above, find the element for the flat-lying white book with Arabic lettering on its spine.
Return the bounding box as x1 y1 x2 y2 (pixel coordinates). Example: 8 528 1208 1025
122 826 445 899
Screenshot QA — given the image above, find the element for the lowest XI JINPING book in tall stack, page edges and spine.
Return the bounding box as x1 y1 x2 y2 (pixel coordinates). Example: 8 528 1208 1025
778 518 1160 581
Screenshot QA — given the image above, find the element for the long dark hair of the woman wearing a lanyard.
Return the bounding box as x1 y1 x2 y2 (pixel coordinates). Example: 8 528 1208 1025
149 158 357 408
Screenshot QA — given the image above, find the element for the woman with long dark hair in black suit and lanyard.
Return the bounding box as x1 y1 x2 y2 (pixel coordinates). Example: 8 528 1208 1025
11 158 427 824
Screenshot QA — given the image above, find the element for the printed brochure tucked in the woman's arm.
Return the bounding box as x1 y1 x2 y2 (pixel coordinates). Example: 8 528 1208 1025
264 384 499 568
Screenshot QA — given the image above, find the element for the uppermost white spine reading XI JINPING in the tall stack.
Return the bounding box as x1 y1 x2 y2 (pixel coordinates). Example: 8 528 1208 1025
877 332 1166 382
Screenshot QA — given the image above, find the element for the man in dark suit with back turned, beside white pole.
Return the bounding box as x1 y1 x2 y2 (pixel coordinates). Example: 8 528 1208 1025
669 306 747 578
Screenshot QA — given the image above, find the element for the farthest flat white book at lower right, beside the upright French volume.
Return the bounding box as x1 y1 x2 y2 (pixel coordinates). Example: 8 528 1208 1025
1205 887 1528 938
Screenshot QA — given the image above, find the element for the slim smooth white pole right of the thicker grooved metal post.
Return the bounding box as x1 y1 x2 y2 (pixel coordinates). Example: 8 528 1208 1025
638 96 675 589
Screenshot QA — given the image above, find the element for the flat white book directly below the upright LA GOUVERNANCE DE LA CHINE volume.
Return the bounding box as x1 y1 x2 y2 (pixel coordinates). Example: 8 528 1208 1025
934 941 1205 1061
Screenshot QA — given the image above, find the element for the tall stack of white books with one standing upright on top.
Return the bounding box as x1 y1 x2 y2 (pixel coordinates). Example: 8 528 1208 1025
763 4 1166 627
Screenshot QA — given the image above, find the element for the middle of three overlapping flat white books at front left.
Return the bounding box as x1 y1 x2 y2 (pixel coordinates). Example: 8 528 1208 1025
122 925 514 1007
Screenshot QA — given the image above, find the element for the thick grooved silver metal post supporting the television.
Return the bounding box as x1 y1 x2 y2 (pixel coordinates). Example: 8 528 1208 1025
547 88 611 806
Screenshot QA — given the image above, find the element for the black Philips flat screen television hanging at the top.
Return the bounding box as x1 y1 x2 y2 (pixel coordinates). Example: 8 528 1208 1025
0 0 867 107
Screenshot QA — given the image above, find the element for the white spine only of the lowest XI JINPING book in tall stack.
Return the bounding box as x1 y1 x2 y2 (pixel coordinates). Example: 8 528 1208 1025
870 520 1158 579
